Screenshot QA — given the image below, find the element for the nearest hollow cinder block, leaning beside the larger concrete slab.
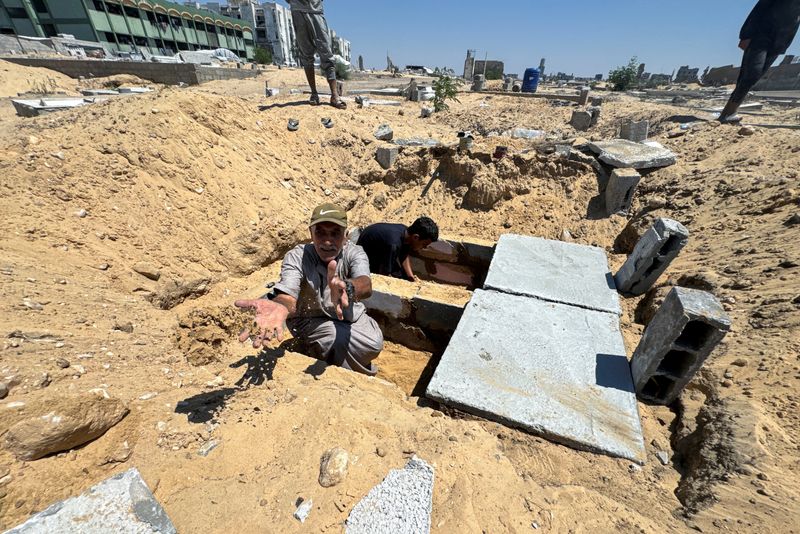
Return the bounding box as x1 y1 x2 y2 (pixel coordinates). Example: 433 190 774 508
631 287 731 404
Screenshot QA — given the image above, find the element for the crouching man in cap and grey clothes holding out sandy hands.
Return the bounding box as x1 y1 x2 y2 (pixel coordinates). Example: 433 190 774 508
235 204 383 376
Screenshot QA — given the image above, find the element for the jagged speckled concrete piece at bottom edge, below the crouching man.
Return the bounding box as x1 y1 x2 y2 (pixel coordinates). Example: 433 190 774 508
345 456 434 534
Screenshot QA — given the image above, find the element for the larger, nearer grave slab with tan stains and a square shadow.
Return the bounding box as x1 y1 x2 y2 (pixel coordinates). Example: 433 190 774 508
427 290 645 463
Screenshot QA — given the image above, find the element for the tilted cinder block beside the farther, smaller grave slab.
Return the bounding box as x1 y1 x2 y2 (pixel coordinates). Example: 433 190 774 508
614 219 689 295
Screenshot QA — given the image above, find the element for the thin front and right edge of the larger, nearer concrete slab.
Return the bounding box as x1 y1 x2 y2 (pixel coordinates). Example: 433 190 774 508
425 374 647 465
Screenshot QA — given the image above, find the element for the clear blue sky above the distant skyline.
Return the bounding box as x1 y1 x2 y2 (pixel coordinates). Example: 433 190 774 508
241 0 800 76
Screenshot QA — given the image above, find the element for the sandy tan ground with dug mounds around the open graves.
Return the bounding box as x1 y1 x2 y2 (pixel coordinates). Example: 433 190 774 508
0 63 800 533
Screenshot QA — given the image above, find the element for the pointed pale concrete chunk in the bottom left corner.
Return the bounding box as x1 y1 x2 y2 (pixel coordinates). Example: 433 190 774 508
6 469 177 534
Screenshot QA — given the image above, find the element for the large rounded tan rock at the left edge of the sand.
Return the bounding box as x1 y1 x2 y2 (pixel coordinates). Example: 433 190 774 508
3 395 128 461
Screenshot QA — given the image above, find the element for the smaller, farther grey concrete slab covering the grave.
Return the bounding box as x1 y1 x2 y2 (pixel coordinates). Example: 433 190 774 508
484 234 621 315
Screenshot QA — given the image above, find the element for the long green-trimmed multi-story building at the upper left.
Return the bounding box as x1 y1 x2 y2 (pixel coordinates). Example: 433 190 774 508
0 0 255 59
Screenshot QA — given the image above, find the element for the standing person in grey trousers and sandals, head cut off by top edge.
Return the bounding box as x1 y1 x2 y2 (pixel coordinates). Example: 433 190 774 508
286 0 347 109
